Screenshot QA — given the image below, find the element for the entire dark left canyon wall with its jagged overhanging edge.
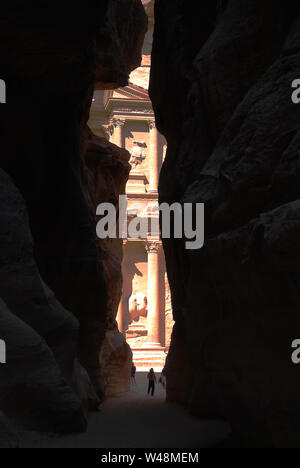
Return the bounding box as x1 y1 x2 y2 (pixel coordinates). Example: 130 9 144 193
0 0 147 438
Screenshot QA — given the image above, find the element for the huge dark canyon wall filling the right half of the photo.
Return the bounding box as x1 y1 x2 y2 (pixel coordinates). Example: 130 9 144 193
150 0 300 447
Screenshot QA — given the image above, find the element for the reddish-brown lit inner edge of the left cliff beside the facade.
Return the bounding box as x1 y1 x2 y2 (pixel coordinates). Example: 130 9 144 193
85 131 132 396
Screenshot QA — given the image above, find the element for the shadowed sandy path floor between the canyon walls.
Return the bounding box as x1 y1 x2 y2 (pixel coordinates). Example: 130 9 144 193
21 372 230 448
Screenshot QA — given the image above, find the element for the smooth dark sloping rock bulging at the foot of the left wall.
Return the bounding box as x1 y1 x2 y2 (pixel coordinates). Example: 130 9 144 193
0 171 86 431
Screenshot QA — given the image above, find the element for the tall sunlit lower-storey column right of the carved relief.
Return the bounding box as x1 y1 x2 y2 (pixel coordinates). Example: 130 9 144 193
146 241 161 348
